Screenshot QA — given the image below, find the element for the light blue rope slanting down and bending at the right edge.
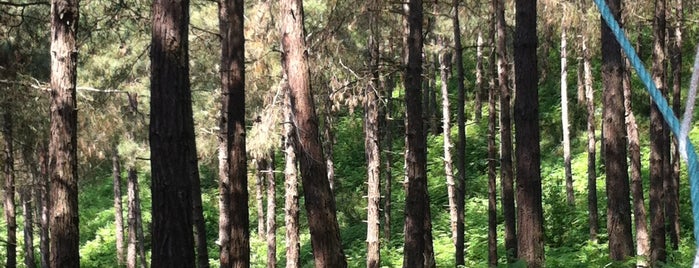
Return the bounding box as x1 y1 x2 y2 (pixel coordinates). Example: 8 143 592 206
595 0 699 253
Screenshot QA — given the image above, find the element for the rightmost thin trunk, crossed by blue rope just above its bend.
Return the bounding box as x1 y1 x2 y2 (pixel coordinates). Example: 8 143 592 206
666 0 684 250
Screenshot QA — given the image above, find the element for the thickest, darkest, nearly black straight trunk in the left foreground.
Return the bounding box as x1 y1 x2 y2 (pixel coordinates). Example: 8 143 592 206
150 0 197 267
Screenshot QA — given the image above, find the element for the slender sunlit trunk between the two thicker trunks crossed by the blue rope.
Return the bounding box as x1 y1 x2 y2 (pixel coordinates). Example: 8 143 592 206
623 56 650 267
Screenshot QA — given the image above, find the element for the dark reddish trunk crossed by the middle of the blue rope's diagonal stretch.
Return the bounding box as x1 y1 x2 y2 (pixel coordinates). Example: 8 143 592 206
649 0 670 266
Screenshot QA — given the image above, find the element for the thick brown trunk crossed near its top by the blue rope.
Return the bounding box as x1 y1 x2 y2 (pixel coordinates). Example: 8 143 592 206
601 0 634 260
